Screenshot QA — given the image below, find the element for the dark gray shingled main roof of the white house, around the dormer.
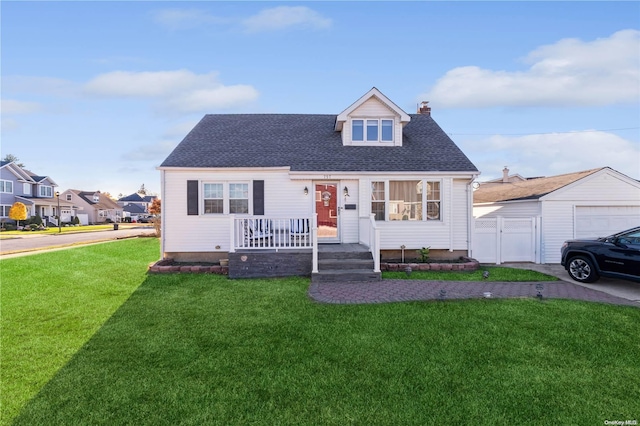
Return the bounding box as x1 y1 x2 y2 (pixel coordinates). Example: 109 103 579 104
161 114 478 172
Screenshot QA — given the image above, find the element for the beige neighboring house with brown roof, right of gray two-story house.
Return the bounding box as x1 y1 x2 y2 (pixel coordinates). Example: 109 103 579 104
60 189 122 224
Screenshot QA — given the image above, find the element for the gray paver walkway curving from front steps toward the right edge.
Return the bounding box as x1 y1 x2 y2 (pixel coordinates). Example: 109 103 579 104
308 280 640 308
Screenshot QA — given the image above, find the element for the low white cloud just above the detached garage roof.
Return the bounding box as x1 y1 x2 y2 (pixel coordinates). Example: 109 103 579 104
460 131 640 180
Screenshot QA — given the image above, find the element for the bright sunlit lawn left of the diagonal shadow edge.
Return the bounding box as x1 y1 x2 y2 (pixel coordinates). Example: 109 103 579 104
0 238 159 425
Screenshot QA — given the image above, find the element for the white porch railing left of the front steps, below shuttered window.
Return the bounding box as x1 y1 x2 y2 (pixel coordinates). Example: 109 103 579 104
229 215 317 252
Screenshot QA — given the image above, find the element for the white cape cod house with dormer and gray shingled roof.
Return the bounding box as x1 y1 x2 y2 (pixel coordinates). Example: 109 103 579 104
159 88 479 277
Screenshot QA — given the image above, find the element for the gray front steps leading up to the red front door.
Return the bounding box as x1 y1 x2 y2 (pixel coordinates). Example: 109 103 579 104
311 244 382 282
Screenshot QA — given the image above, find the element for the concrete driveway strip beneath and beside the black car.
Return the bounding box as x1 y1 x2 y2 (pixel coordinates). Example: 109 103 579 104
500 263 640 303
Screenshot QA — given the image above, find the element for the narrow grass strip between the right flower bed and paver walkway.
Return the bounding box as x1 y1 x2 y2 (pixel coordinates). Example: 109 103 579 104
382 266 558 282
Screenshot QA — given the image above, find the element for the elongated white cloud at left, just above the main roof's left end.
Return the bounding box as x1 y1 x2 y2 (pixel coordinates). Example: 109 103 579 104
85 70 258 113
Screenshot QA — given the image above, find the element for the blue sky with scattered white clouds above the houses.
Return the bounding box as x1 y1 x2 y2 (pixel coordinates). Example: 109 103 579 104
0 1 640 196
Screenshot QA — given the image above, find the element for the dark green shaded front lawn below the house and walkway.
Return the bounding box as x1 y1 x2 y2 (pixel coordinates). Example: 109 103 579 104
3 253 640 425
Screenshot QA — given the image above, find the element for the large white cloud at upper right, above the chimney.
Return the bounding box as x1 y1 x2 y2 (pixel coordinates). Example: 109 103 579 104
419 30 640 108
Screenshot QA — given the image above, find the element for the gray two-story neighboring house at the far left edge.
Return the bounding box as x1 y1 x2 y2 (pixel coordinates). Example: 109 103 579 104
0 161 74 225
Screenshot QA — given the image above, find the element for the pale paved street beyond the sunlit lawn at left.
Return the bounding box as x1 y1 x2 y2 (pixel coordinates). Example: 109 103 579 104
0 226 155 259
